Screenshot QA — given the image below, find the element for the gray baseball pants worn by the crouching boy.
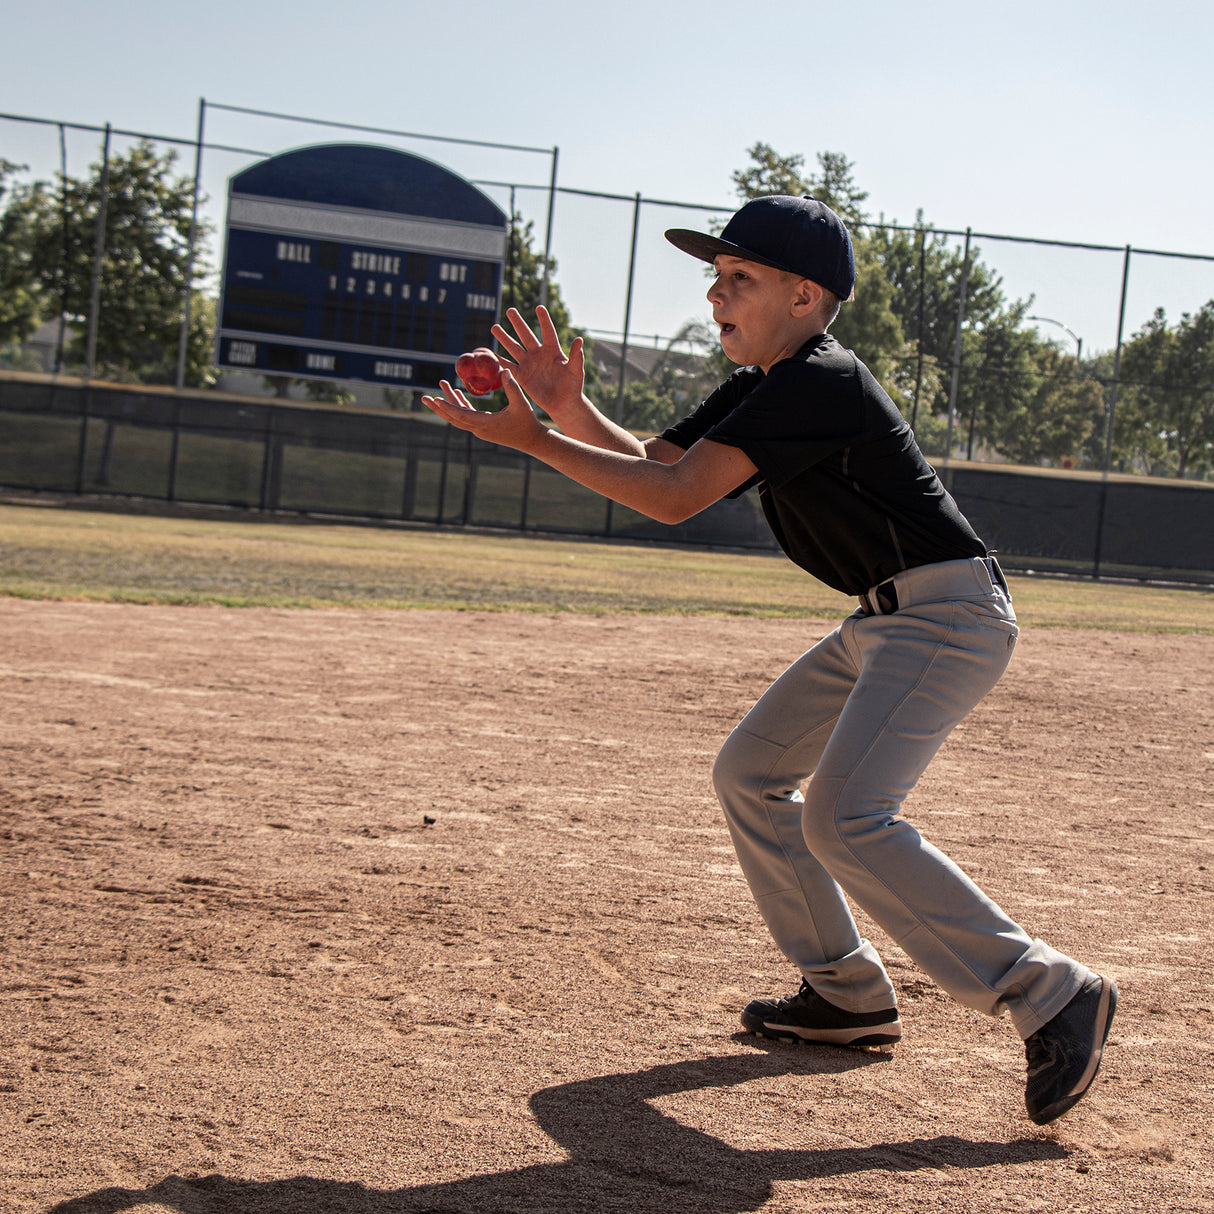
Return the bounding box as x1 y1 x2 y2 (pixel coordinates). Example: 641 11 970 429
713 557 1090 1038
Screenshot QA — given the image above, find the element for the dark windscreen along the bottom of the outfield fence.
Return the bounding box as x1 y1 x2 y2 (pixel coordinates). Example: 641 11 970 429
0 376 1214 584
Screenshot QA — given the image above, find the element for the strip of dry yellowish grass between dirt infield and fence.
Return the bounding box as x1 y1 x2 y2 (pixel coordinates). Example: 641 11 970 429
0 504 1214 634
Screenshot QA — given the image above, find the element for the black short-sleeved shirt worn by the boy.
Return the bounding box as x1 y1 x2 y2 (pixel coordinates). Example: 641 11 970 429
662 333 987 595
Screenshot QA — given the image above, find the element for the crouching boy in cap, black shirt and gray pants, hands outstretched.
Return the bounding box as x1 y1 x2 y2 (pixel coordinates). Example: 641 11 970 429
426 195 1117 1125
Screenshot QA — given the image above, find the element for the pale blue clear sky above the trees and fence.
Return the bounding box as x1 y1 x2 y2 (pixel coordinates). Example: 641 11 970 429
0 0 1214 354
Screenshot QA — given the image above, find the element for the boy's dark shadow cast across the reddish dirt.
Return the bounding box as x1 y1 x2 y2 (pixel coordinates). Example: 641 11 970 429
49 1038 1067 1214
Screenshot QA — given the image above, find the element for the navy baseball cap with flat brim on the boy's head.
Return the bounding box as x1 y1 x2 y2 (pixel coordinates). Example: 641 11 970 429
666 194 856 300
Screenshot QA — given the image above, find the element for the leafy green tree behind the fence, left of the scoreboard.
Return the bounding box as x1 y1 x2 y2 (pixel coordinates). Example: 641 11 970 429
10 141 210 382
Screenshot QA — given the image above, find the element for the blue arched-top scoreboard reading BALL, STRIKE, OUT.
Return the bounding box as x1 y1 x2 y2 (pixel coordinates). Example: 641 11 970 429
216 144 509 388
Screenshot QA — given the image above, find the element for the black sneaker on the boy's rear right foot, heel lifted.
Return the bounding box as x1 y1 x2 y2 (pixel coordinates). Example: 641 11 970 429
1025 975 1117 1125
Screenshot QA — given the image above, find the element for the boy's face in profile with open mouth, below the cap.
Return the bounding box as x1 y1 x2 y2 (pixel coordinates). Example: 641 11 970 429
708 254 821 371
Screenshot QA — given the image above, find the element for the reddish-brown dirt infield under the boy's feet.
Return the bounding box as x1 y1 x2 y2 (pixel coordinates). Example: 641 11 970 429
0 600 1214 1214
